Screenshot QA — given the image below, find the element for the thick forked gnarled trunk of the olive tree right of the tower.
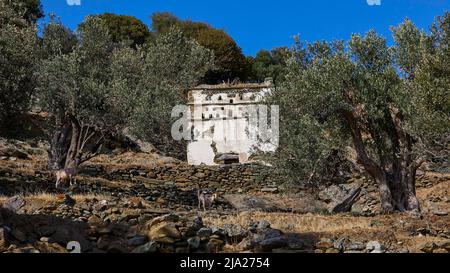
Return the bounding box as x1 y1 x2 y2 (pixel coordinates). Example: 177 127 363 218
341 98 420 213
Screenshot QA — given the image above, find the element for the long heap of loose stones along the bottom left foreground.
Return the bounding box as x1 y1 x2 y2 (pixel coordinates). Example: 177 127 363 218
0 196 313 253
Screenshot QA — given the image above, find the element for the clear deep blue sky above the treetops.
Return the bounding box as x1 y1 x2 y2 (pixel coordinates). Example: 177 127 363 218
41 0 450 55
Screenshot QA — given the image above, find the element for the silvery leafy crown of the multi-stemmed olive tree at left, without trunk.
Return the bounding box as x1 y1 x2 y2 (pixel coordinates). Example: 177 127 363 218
37 18 127 132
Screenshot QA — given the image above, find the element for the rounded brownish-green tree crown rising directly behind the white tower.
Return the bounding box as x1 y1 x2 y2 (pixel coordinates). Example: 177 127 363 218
152 13 249 83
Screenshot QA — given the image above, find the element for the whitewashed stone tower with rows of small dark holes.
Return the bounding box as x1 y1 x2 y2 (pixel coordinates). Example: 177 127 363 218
187 78 276 165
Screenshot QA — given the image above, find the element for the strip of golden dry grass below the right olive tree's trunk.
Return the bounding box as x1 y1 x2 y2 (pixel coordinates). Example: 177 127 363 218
203 212 450 253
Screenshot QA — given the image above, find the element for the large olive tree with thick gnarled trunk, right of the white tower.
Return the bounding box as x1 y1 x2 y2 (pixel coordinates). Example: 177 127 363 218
270 17 450 212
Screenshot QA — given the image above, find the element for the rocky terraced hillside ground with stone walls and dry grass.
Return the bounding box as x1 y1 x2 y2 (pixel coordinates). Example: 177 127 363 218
0 137 450 253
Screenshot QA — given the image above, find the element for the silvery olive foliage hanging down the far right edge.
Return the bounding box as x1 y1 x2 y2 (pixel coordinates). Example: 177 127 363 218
392 15 450 169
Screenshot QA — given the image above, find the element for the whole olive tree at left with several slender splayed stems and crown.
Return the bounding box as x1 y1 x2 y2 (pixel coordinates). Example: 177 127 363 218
37 17 129 169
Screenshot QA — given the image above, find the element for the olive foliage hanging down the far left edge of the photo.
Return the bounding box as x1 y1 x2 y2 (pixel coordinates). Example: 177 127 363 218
0 0 37 123
